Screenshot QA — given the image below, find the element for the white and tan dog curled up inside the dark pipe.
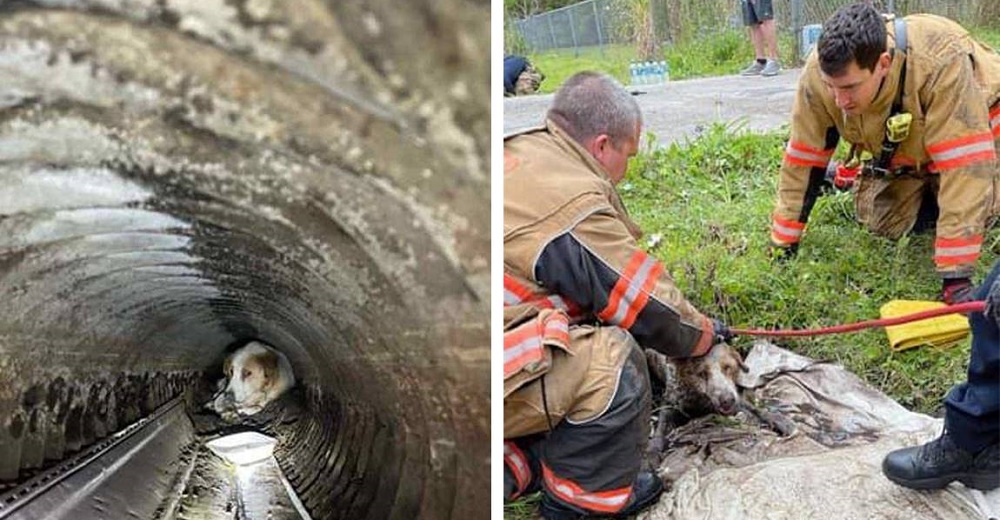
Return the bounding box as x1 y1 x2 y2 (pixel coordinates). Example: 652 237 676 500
205 341 295 422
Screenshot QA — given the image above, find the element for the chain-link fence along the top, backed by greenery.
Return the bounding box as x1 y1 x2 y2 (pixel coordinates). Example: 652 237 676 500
507 0 1000 59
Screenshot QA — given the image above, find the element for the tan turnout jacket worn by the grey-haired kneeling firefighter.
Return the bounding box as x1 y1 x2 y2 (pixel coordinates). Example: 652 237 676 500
504 122 713 364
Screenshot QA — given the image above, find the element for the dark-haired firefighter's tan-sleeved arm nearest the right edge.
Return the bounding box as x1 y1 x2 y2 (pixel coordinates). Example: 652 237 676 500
921 54 998 280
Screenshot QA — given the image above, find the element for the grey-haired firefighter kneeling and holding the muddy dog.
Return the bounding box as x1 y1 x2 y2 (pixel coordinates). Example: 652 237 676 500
504 72 729 519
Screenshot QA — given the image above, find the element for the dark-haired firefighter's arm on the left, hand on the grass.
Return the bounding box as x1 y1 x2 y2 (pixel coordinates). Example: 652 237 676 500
771 67 840 252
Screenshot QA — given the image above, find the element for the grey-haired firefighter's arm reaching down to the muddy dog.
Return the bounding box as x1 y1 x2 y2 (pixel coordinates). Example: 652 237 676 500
533 212 715 357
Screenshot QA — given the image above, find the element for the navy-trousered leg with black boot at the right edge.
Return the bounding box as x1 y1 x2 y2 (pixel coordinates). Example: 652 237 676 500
882 261 1000 490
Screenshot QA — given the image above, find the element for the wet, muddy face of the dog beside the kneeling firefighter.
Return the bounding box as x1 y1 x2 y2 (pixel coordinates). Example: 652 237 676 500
674 343 747 415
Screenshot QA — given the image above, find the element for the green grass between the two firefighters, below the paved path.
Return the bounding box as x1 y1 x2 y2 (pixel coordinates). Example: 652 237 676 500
504 123 1000 520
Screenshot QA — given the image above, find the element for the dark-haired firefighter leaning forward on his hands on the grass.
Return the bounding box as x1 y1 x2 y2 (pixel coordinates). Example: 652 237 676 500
771 3 1000 303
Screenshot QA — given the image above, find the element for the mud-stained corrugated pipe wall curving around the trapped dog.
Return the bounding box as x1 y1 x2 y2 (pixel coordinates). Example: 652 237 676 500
0 0 490 518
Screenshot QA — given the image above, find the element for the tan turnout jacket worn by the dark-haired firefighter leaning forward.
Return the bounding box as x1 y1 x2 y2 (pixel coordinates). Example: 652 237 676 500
771 15 1000 278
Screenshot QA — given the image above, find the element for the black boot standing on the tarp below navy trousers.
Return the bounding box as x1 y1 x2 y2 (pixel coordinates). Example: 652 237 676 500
882 432 1000 490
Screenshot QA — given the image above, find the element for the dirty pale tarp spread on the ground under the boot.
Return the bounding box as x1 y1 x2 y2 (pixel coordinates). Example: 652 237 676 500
638 342 1000 520
